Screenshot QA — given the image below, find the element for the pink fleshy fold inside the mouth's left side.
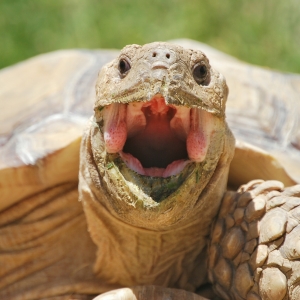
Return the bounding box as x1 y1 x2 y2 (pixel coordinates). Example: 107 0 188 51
103 103 127 153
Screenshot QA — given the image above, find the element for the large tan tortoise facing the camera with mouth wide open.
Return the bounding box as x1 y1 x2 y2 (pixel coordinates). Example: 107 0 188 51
0 40 300 299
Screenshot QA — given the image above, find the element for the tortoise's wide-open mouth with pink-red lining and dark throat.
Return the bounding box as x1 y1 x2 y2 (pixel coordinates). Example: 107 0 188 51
103 94 213 178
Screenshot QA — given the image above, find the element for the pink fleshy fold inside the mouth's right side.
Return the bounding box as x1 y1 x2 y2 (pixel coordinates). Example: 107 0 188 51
186 108 213 162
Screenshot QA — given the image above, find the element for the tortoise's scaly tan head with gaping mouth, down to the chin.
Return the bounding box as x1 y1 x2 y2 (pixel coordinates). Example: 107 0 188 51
82 43 234 228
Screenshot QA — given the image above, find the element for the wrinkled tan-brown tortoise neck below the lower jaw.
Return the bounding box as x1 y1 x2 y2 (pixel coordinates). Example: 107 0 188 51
81 176 211 291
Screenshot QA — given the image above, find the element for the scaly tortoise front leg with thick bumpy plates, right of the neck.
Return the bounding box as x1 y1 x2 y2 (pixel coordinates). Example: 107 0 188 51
208 180 300 300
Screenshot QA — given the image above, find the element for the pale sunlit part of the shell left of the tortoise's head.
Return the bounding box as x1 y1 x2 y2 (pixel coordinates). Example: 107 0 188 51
0 50 118 169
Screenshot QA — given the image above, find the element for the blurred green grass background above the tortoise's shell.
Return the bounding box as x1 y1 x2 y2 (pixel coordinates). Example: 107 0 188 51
0 0 300 73
